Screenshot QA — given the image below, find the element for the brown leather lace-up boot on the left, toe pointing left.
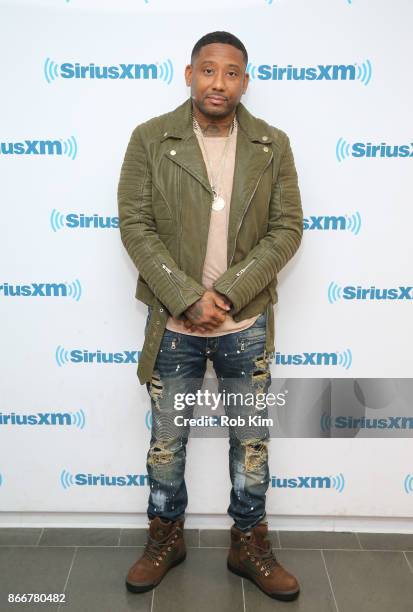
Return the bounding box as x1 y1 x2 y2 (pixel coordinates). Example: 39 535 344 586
126 517 186 593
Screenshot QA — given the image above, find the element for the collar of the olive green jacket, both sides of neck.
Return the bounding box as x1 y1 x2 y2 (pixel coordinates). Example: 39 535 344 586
162 98 272 144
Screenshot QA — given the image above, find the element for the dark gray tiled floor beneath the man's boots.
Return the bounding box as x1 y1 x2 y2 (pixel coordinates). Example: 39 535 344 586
0 529 413 612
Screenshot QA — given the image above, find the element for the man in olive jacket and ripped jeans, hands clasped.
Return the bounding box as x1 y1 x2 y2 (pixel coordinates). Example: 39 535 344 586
118 32 303 601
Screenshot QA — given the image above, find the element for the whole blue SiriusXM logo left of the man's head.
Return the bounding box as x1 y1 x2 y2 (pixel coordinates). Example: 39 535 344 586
43 57 174 85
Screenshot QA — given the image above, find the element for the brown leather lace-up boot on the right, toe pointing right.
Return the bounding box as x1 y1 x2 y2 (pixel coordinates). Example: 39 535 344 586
227 523 300 601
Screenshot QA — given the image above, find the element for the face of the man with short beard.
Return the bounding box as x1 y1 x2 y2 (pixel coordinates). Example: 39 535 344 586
185 43 248 118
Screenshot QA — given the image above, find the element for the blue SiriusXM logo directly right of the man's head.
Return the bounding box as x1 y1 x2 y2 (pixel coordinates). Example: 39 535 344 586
247 60 372 85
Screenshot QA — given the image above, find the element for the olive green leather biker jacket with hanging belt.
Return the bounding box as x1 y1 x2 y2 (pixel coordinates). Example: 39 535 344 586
118 98 303 384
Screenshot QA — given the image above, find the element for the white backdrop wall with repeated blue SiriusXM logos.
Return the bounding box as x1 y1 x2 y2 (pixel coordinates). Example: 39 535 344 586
0 0 413 524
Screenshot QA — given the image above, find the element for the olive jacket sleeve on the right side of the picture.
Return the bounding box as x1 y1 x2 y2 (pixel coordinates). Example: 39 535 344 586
214 132 303 315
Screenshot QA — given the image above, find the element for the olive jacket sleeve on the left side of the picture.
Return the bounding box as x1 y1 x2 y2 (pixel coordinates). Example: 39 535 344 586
118 127 205 317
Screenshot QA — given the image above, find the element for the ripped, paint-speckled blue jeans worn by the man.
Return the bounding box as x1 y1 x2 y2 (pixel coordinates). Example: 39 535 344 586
143 313 271 531
